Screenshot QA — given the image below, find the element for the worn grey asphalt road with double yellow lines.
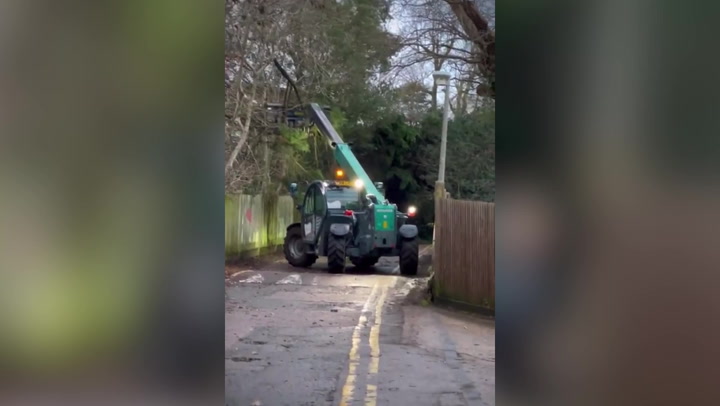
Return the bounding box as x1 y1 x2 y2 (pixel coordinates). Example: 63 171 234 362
225 251 495 406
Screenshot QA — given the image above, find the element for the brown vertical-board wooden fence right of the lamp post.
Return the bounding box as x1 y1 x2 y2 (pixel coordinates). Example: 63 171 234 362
433 199 495 311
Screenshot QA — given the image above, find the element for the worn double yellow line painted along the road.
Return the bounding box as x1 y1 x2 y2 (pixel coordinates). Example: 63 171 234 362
340 283 388 406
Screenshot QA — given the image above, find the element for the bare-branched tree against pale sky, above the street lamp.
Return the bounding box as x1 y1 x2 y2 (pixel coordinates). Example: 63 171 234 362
394 0 495 114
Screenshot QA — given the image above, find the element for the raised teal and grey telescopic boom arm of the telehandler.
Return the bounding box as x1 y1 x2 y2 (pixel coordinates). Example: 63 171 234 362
310 103 386 204
